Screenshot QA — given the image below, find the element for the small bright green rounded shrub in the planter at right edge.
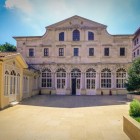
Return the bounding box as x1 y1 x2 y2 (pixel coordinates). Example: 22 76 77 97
129 100 140 117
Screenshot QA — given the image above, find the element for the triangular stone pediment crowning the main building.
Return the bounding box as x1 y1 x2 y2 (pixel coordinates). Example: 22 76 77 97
46 16 107 30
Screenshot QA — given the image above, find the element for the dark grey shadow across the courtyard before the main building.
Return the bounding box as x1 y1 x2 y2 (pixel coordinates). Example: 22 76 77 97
20 95 129 108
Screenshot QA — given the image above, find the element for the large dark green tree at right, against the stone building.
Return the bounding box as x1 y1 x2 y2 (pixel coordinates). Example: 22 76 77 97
126 58 140 91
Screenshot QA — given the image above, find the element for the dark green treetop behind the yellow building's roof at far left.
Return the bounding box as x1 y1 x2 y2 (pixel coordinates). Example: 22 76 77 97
0 42 16 52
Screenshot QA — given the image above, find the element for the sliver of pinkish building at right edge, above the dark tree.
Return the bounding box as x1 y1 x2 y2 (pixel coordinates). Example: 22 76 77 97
132 28 140 59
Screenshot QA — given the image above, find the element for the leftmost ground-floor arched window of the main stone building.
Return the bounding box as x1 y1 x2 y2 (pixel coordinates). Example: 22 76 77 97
42 69 52 88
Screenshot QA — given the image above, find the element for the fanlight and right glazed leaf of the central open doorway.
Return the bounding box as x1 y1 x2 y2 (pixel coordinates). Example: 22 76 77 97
71 68 81 89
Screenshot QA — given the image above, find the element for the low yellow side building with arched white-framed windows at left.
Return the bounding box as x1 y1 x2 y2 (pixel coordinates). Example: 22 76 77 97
0 52 39 109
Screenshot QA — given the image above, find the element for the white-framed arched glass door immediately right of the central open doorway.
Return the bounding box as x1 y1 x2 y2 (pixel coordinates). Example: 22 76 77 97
86 68 96 89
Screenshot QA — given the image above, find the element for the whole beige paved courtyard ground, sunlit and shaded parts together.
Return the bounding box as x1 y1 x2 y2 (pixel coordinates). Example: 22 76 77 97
0 95 129 140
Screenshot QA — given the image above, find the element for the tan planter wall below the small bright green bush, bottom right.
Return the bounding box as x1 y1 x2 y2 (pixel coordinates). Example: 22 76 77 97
123 116 140 140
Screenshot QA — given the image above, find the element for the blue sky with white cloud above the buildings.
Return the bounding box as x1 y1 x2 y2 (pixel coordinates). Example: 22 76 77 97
0 0 140 45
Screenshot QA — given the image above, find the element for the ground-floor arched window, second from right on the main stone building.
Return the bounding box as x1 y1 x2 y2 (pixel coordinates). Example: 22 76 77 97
101 68 111 88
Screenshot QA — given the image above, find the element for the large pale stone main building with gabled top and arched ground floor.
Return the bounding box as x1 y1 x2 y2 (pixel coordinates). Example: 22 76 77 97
14 16 133 95
